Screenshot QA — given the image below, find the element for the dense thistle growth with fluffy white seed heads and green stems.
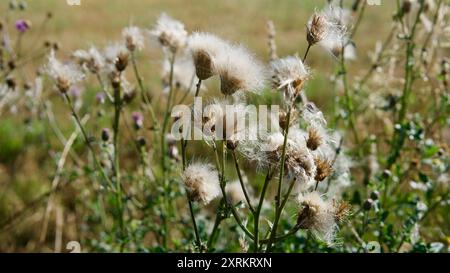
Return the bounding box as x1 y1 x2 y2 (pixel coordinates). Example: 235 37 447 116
0 0 450 253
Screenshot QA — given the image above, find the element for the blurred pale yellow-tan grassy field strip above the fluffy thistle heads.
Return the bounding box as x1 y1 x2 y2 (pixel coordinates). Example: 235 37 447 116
0 0 395 89
